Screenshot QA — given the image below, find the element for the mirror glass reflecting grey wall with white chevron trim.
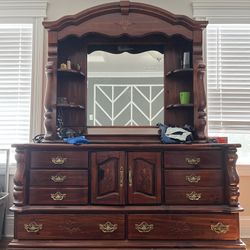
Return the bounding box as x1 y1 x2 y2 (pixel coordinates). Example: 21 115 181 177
87 50 164 126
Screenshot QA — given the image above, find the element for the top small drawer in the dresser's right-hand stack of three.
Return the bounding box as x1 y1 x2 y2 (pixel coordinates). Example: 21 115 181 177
164 150 223 169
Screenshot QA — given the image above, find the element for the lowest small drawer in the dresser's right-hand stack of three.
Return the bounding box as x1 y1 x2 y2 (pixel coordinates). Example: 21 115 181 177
165 186 224 205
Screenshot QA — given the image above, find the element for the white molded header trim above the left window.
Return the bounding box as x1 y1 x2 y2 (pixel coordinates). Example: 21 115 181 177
0 0 48 17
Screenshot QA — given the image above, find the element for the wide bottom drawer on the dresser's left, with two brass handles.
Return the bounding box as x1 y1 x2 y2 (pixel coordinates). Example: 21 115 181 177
15 214 124 240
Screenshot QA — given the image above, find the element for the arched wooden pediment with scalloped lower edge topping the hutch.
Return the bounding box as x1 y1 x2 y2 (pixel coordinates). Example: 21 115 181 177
44 1 206 40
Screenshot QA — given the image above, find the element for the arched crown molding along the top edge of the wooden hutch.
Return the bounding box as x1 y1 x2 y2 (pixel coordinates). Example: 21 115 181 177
43 1 207 31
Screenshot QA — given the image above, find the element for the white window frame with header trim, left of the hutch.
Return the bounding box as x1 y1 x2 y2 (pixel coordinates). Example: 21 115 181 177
0 0 48 168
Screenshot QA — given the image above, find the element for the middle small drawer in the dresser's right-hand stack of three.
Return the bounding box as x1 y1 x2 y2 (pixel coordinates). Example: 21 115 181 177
164 170 223 187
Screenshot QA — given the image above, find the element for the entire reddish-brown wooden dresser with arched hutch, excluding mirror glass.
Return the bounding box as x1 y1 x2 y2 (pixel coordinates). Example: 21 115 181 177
9 1 246 249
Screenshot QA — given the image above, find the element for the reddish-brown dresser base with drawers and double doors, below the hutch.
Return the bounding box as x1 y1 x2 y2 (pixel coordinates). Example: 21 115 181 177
9 144 246 249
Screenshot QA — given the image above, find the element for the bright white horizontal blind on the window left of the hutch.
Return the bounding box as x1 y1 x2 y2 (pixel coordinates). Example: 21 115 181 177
0 24 32 148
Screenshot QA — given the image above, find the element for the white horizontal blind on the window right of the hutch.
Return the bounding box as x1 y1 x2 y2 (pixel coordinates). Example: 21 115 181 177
207 24 250 133
